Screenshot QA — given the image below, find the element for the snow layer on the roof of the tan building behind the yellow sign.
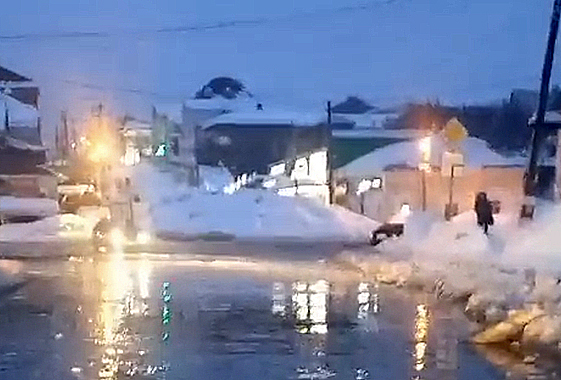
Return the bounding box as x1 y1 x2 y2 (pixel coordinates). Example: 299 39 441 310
337 135 526 177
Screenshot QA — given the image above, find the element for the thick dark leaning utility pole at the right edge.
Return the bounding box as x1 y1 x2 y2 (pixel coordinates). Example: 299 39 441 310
521 0 561 217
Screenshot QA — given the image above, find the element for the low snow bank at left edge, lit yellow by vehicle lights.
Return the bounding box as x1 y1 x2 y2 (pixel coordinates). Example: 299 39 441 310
0 214 93 242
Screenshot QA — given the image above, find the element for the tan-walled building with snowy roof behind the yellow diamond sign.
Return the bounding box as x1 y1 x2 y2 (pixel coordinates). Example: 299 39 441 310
334 134 526 221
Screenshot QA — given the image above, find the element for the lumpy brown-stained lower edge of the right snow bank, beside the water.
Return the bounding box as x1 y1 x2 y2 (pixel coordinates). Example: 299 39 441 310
343 248 561 345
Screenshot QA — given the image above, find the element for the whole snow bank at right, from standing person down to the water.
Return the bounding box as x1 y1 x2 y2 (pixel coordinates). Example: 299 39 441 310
336 204 561 345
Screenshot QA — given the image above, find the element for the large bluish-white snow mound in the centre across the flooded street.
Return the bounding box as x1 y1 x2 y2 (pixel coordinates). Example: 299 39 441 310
133 164 378 242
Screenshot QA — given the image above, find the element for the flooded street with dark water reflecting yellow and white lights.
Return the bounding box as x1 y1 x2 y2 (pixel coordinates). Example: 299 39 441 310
0 245 524 380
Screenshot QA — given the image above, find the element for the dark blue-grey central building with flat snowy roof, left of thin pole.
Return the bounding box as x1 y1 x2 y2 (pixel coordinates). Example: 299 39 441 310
197 107 330 175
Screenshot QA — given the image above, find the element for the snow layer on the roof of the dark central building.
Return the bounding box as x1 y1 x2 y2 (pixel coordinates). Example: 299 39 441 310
202 109 326 129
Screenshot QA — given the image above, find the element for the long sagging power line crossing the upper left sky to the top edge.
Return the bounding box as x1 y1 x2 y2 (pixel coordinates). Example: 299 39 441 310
0 0 400 41
